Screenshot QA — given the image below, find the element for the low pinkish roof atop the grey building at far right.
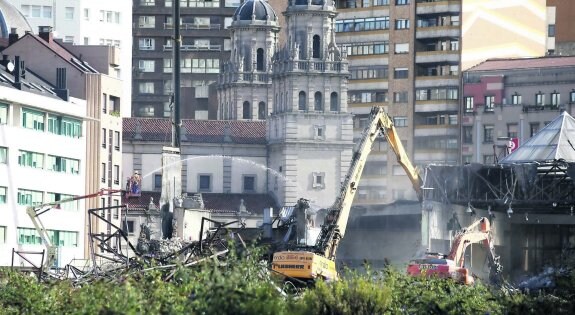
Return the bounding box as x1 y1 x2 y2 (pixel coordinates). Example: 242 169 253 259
467 56 575 71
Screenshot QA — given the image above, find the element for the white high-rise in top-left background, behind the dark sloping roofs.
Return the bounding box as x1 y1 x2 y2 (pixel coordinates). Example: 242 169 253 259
10 0 132 117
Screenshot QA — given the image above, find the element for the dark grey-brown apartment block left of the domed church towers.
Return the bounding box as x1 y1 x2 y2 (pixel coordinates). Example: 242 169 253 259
132 0 240 119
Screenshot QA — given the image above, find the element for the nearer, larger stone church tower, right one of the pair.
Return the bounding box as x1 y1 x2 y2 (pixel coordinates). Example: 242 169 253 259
267 0 353 207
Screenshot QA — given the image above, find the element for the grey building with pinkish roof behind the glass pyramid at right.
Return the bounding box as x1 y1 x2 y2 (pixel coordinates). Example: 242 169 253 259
461 56 575 164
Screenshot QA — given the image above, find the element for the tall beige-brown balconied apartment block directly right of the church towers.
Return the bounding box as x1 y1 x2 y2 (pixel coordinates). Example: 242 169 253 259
336 0 461 205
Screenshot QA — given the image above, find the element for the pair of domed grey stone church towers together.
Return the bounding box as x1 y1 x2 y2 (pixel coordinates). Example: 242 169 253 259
218 0 353 206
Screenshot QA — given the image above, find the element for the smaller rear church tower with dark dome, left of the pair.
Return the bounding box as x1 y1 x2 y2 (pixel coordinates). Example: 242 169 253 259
218 0 279 120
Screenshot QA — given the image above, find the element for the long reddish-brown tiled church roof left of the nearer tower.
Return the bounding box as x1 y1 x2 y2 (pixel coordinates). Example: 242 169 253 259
123 117 266 144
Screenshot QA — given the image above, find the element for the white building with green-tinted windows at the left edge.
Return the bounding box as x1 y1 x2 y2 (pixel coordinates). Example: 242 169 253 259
0 65 87 267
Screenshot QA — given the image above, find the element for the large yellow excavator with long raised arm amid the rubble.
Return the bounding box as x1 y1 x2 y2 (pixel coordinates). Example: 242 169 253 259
272 106 422 282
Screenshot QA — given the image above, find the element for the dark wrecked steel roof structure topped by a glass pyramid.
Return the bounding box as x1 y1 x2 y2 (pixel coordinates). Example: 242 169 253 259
424 111 575 214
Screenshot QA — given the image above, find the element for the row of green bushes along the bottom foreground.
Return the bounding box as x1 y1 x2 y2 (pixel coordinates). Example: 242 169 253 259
0 252 575 315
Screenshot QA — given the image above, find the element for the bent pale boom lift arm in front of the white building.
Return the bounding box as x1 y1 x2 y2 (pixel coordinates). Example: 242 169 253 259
26 189 122 272
